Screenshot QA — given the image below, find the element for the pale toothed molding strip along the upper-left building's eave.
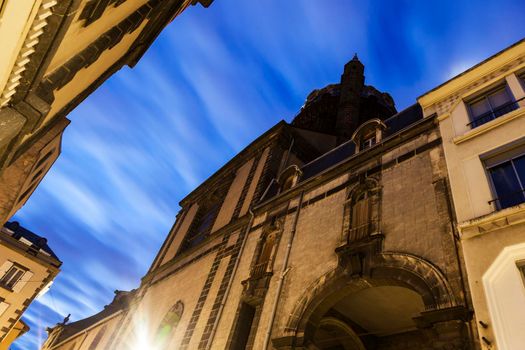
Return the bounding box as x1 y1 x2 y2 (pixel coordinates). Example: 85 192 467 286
0 0 58 108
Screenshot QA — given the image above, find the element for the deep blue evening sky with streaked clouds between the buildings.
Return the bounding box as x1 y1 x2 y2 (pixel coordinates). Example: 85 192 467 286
9 0 525 349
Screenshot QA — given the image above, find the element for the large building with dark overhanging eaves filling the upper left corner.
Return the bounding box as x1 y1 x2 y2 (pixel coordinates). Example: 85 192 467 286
0 0 212 227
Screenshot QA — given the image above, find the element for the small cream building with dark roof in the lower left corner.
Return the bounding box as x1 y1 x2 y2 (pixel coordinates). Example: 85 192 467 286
0 221 62 350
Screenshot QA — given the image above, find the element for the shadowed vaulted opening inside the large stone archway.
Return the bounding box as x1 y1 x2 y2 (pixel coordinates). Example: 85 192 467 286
305 281 427 350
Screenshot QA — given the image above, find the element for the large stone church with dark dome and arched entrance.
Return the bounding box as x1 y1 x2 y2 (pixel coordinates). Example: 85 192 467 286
43 57 479 350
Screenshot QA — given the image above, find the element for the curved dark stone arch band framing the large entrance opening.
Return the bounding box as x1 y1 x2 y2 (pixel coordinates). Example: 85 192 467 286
277 252 457 347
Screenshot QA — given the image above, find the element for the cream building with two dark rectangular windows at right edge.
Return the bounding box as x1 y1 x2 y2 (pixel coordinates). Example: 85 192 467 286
418 39 525 349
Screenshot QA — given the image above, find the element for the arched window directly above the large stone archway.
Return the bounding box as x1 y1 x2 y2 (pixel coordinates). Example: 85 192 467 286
343 178 380 243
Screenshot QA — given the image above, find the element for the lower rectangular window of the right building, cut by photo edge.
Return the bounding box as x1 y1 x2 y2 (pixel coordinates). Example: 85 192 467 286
484 145 525 209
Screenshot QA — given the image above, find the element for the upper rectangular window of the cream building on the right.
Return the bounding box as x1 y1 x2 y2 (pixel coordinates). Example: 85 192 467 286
467 84 518 129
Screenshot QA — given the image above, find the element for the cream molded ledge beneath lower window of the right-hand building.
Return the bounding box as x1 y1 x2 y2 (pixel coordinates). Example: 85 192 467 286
458 203 525 240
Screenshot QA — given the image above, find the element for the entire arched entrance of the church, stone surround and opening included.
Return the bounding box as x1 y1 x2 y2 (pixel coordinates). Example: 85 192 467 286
273 248 468 350
